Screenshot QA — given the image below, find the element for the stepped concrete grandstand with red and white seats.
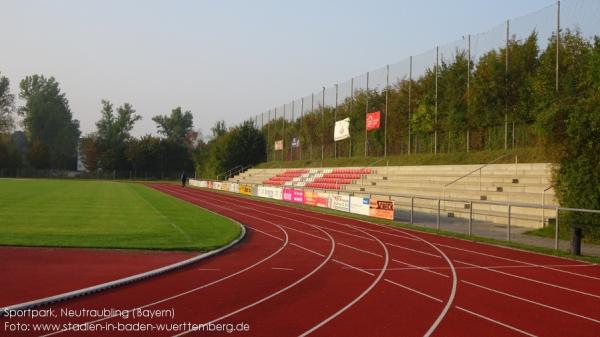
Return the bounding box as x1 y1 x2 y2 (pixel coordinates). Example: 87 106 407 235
230 163 557 228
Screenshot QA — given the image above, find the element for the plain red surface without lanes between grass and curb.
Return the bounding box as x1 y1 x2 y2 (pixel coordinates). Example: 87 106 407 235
0 247 192 306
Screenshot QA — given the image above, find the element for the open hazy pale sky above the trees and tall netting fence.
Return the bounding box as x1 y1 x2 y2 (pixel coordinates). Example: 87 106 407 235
0 0 553 135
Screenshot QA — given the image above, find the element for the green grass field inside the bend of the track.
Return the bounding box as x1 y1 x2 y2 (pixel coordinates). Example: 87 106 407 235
0 179 240 250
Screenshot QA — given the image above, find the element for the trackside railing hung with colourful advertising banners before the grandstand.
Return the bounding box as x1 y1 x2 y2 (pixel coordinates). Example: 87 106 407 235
190 180 600 256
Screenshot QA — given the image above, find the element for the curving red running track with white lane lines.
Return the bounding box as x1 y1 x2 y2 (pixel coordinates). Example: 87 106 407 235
2 184 600 336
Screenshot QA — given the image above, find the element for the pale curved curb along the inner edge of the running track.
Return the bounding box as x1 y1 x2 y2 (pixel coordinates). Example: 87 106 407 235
0 218 246 317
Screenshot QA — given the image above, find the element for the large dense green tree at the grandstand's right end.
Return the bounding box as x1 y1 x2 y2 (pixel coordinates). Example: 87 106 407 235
533 30 600 242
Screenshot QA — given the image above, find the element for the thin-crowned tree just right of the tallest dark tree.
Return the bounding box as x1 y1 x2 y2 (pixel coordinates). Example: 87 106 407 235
96 100 142 170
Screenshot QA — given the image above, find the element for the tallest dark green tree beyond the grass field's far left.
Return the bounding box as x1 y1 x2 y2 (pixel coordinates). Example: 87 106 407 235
19 75 80 169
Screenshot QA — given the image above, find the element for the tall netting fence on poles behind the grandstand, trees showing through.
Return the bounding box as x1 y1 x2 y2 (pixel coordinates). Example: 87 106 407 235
253 0 600 161
